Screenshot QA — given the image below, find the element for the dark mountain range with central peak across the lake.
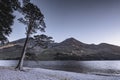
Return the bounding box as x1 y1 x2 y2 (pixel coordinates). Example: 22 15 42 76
0 38 120 60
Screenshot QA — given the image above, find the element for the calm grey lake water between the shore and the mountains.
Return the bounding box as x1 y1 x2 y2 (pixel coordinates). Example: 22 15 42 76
0 60 120 73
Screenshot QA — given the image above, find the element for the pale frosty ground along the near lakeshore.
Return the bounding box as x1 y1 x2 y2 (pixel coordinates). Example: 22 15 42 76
0 67 120 80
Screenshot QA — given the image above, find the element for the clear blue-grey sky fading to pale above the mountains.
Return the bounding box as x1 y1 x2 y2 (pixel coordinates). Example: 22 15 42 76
9 0 120 46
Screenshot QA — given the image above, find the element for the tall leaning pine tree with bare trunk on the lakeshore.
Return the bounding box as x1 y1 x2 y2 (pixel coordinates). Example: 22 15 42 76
16 0 46 70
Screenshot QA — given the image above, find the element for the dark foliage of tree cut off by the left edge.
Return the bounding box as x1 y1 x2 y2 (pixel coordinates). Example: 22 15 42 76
0 0 19 44
